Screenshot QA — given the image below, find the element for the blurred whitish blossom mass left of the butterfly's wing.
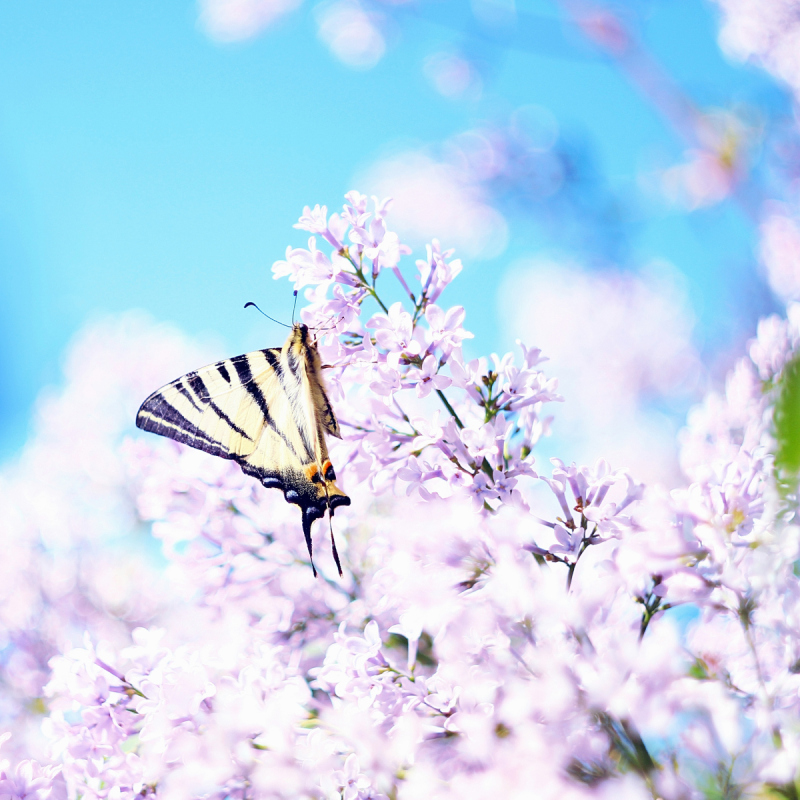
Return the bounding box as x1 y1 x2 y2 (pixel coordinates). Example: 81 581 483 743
0 313 213 764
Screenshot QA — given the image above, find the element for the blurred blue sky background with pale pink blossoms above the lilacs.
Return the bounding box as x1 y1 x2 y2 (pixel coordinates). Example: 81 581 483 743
0 0 800 484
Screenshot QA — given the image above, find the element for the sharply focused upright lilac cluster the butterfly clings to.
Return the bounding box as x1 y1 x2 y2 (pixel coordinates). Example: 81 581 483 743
273 192 561 511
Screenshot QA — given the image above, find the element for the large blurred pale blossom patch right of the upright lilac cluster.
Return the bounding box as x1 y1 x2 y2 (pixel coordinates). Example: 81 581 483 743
501 263 701 483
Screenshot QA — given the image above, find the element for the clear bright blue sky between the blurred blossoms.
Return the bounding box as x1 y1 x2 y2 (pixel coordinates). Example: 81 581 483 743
0 0 788 456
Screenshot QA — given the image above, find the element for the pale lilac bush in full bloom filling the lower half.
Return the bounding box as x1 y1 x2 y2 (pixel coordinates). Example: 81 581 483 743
0 192 800 800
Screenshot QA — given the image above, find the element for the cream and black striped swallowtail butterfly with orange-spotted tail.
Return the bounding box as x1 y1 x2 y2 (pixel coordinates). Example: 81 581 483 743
136 324 350 577
